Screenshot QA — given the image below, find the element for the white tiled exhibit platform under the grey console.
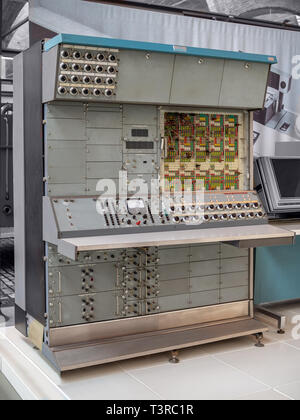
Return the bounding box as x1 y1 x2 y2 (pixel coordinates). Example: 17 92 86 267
0 303 300 400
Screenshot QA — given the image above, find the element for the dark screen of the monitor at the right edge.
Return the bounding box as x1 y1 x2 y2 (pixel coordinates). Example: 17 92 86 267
272 158 300 198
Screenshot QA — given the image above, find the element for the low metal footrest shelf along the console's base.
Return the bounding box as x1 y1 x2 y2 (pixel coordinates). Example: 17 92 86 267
44 319 268 372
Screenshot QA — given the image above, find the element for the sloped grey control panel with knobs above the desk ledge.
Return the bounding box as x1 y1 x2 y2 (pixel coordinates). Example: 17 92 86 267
51 192 266 237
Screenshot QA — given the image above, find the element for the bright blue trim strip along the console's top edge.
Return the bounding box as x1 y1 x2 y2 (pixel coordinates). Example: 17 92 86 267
44 34 277 64
